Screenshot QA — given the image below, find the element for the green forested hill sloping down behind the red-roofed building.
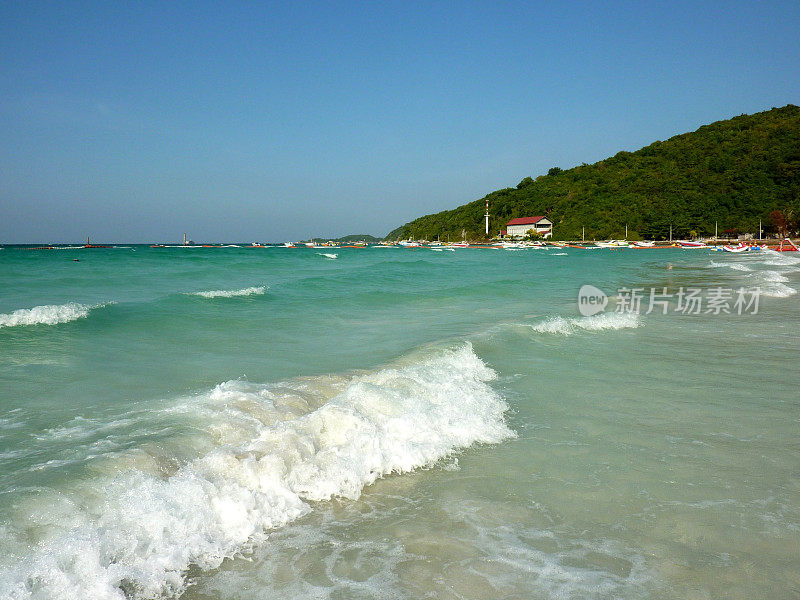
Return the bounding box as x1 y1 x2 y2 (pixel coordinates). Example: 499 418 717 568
386 104 800 240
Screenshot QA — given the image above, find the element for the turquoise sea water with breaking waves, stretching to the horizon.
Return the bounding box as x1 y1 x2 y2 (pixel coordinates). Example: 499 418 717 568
0 246 800 600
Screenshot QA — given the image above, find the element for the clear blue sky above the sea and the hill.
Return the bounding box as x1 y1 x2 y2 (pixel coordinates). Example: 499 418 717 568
0 1 800 243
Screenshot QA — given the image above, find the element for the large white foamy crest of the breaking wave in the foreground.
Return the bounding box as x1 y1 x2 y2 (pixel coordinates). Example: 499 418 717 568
0 344 514 600
